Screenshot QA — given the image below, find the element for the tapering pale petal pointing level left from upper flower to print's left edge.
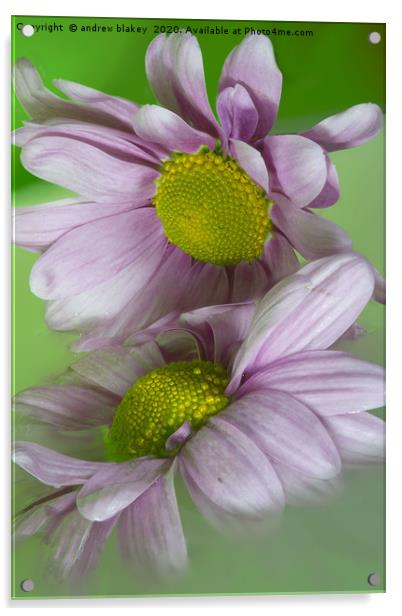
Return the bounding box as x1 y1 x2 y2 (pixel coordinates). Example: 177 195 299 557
14 199 131 251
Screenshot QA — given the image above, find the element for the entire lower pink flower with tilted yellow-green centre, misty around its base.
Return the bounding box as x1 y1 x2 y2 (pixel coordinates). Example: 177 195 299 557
14 254 384 573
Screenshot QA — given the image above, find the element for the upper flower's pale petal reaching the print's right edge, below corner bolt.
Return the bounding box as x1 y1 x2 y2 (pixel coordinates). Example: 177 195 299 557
303 103 383 152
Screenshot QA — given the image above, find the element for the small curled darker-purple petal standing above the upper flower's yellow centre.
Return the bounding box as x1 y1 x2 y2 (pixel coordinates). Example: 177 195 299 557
217 83 258 142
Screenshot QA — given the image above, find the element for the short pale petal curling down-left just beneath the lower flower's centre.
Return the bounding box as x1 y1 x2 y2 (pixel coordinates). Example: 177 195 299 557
77 458 170 522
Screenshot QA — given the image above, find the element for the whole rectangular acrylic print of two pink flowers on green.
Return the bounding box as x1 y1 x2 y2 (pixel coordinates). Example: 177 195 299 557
12 16 385 599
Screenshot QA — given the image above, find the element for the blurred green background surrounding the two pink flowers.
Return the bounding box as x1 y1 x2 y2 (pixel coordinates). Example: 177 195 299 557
13 17 385 598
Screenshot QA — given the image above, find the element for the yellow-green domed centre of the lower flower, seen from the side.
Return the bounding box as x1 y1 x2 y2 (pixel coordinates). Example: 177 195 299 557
106 360 229 461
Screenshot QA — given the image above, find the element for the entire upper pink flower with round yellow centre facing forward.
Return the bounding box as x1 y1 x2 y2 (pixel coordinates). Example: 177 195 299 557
15 34 383 349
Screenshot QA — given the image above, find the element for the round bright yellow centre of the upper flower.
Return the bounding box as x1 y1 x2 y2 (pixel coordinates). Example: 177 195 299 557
153 151 271 265
